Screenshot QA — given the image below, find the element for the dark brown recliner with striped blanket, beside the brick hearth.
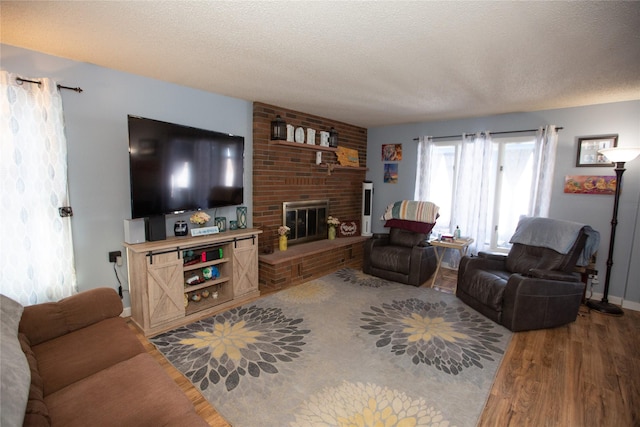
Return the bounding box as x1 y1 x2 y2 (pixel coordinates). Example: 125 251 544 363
362 227 436 286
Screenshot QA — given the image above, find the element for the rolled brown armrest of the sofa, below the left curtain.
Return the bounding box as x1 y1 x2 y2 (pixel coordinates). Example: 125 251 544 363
19 288 122 345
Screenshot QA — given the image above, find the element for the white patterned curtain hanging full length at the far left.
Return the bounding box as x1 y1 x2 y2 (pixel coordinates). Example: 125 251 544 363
0 71 77 305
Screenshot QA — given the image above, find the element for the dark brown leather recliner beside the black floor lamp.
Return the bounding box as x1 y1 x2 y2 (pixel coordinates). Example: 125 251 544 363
456 228 587 332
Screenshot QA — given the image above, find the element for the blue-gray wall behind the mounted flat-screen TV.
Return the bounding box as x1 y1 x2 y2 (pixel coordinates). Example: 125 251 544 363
0 45 253 307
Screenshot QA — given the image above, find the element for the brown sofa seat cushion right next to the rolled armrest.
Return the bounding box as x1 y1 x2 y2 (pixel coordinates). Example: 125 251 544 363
32 317 145 396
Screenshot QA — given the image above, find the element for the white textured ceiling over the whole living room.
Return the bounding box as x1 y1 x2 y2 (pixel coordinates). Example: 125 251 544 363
0 1 640 127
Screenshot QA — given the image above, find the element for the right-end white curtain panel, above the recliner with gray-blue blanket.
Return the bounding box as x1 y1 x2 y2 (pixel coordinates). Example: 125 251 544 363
529 125 558 217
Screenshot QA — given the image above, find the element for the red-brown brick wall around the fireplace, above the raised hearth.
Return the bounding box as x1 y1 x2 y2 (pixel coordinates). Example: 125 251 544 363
253 103 367 253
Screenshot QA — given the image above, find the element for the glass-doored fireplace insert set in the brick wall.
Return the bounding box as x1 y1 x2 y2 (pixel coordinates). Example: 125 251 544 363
282 200 329 245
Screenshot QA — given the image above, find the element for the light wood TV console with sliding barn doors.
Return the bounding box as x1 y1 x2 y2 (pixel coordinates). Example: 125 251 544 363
124 228 262 336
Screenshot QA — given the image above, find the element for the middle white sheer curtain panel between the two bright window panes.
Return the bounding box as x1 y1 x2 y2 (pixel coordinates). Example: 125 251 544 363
451 132 493 253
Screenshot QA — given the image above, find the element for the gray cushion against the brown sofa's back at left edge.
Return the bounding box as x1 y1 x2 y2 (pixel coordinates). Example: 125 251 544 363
0 295 31 426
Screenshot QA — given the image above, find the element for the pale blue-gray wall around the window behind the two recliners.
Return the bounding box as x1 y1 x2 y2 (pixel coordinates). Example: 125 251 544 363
367 101 640 309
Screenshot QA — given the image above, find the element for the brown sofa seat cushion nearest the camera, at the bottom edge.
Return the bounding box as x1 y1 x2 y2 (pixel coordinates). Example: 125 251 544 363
45 353 206 427
